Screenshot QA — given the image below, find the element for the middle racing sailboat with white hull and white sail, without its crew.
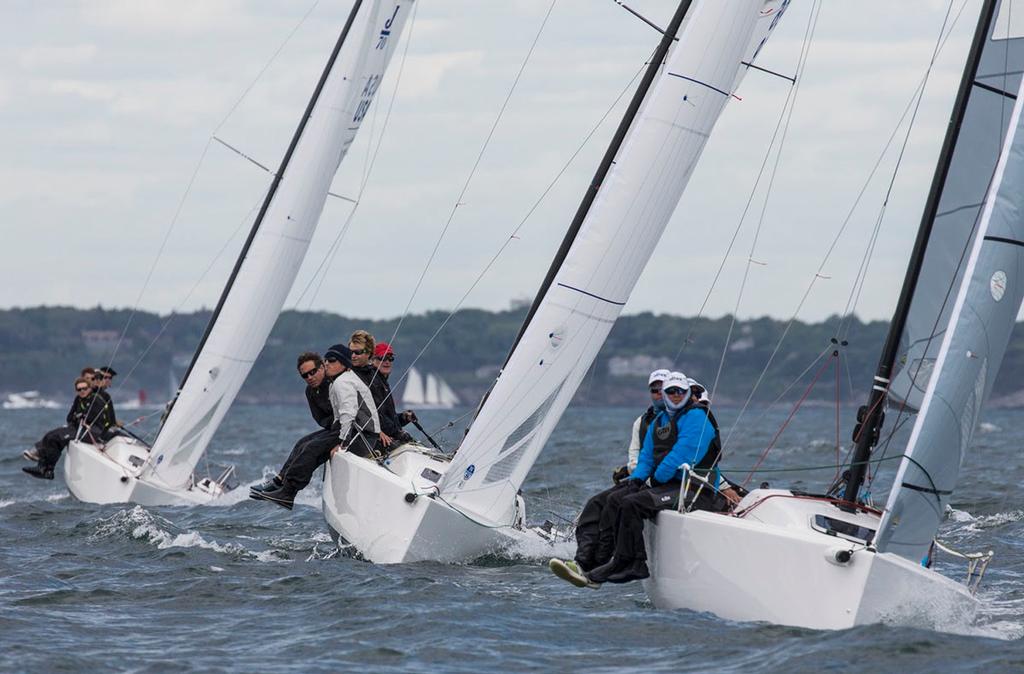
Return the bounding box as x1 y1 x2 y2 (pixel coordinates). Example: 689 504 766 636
323 0 788 563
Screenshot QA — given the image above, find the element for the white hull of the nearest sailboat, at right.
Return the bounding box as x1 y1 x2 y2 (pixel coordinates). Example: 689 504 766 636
644 490 977 629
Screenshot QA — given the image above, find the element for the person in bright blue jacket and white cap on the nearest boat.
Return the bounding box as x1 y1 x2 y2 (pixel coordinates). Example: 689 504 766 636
587 372 726 583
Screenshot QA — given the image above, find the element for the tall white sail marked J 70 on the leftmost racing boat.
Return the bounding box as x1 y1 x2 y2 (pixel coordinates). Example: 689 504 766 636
147 0 414 488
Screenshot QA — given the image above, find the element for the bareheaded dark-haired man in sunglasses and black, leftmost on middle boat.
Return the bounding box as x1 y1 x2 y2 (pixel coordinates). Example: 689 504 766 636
249 351 342 500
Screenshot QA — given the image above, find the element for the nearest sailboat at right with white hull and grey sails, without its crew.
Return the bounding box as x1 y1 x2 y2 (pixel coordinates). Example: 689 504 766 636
645 0 1024 629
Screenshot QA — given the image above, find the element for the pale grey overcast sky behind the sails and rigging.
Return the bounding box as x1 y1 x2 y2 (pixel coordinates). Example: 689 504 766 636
0 0 979 321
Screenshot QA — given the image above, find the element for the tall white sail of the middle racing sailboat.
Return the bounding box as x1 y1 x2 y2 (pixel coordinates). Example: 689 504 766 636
440 0 786 524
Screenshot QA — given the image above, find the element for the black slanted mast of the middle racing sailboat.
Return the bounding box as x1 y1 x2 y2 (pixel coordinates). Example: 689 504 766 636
468 0 693 414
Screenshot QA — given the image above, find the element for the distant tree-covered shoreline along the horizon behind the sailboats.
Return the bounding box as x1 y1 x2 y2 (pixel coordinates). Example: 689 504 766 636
6 306 1024 406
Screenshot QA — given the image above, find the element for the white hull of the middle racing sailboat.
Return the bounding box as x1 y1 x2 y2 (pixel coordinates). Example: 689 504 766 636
324 446 541 564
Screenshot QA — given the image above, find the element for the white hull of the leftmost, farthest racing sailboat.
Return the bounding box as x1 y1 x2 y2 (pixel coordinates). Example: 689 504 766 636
63 436 223 506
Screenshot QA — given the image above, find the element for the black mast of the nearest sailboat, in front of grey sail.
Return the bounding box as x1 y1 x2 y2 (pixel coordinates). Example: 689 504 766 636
843 0 997 503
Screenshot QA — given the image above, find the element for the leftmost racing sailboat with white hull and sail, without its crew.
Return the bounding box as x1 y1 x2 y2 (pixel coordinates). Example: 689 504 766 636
65 0 415 505
